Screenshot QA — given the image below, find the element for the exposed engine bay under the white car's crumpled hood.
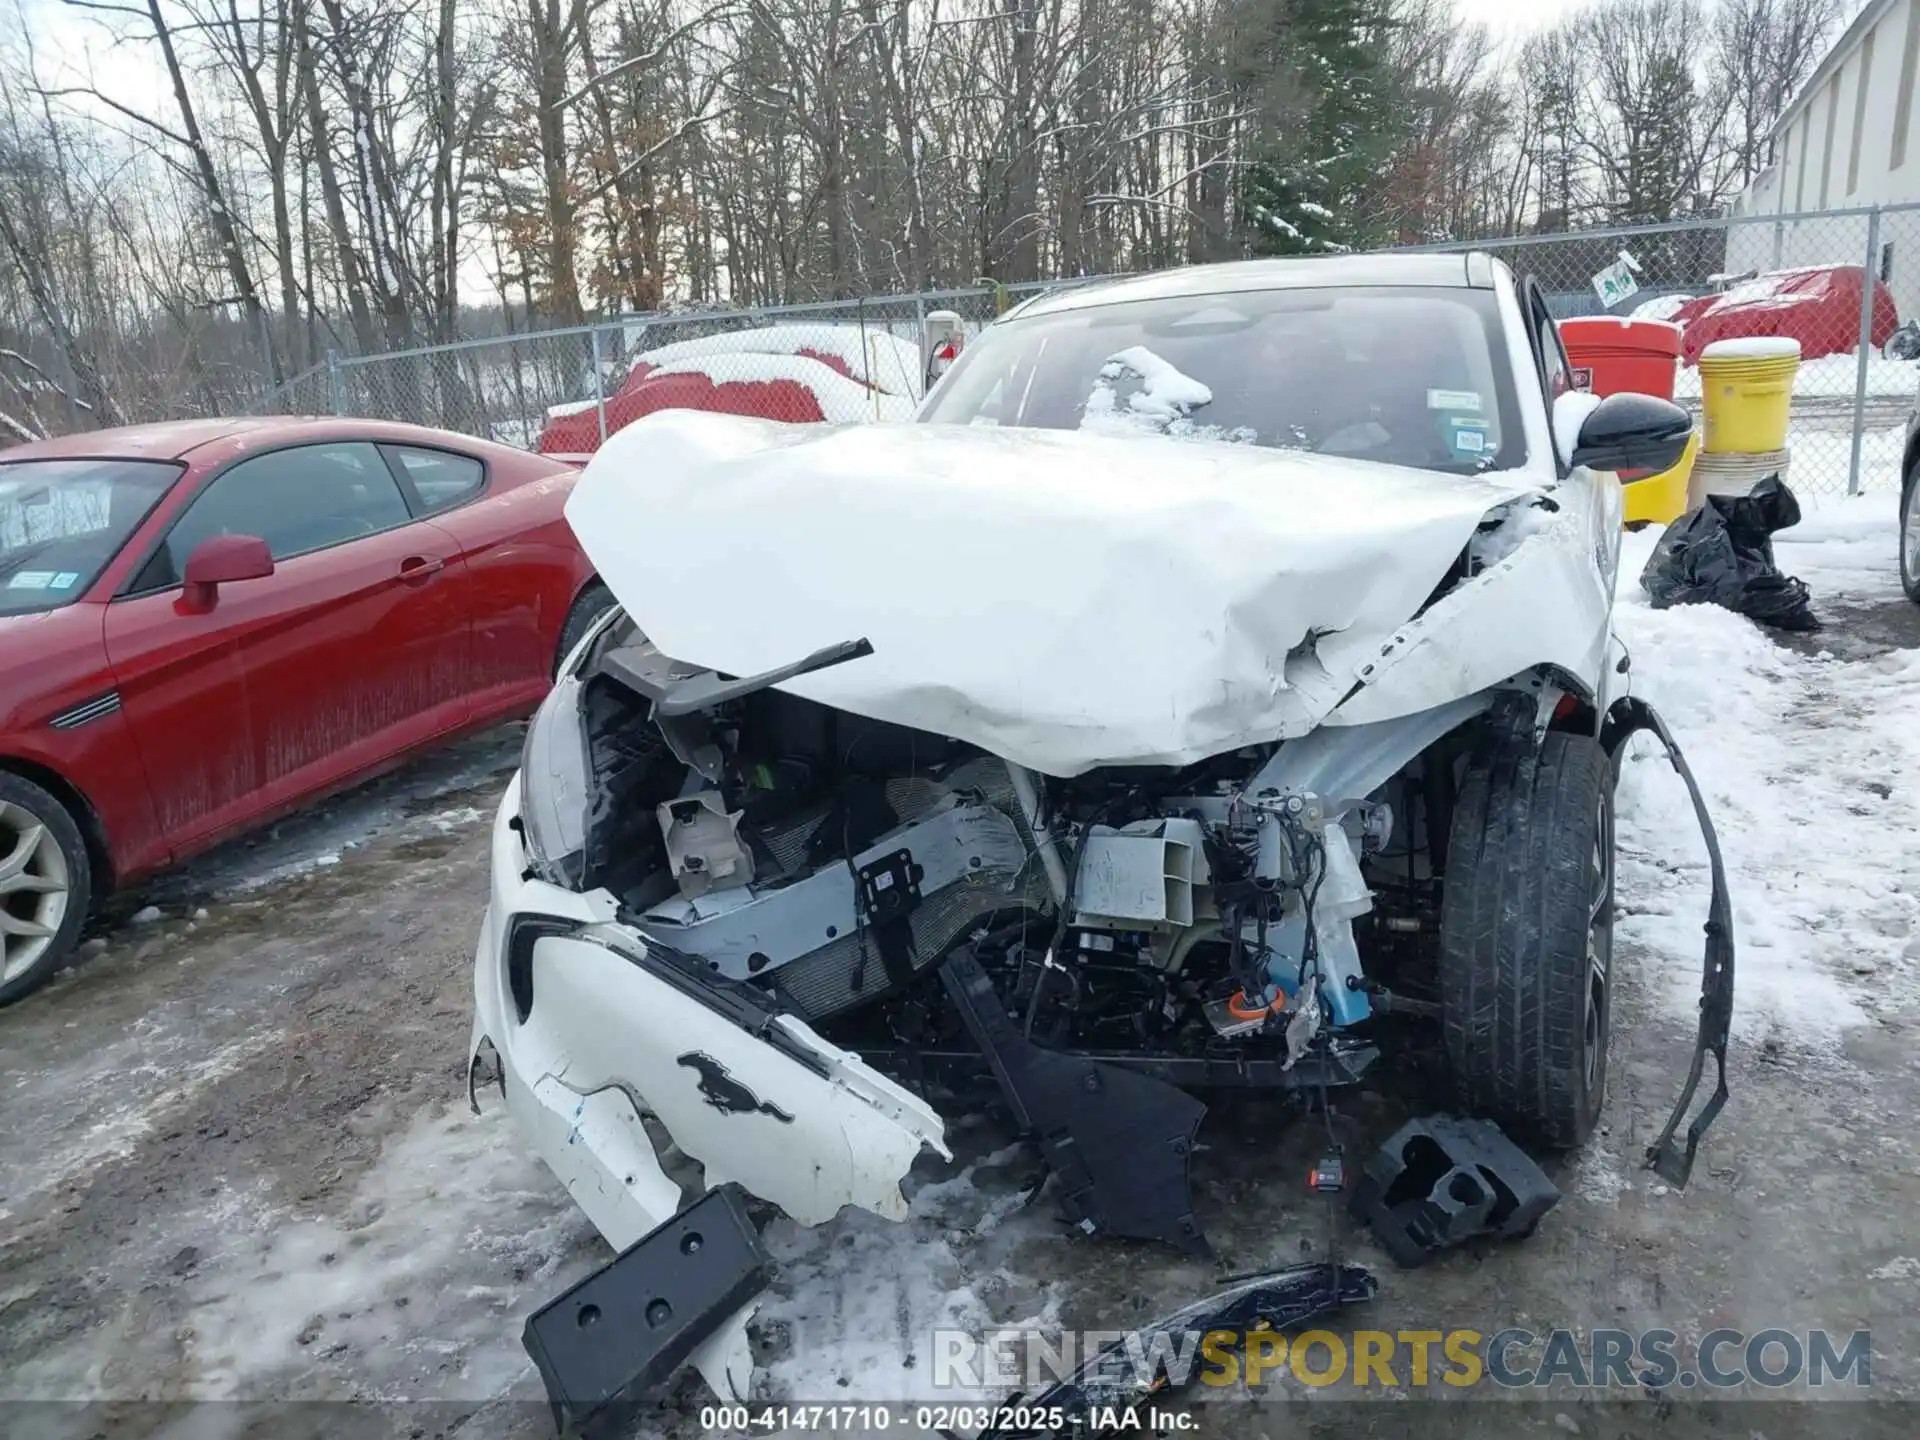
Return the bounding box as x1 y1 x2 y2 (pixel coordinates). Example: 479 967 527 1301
560 622 1446 1083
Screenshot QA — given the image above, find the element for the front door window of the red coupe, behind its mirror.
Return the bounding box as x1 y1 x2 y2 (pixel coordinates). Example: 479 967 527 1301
134 444 413 591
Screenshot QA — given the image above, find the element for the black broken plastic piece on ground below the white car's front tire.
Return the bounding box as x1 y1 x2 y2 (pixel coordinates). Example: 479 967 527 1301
1352 1116 1559 1269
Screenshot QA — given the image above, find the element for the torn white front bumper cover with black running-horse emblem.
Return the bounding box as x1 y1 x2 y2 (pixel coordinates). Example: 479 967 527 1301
468 780 948 1409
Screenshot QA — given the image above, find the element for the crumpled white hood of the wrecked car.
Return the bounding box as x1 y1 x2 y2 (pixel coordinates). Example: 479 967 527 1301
566 411 1538 776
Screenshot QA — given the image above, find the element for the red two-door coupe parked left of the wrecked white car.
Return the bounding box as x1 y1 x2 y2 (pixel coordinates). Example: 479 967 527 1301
0 419 611 1004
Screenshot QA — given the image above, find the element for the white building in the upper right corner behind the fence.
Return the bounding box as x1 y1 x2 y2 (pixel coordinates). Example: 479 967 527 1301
1726 0 1920 317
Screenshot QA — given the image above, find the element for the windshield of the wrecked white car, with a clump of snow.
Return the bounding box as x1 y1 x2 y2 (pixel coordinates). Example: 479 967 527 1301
920 286 1526 472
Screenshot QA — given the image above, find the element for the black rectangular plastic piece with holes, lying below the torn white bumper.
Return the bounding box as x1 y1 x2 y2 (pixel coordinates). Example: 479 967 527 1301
522 1185 772 1436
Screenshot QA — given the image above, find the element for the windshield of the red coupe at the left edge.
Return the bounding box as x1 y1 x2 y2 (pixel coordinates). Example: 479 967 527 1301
0 461 184 614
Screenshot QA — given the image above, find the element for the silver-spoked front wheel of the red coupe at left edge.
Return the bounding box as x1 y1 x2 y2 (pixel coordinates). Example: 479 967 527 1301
0 774 92 1004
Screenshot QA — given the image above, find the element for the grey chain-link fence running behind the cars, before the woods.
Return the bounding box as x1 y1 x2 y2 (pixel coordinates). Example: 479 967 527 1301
257 205 1920 493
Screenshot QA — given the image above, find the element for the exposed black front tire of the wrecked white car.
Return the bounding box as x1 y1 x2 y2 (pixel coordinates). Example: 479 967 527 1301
1440 733 1613 1148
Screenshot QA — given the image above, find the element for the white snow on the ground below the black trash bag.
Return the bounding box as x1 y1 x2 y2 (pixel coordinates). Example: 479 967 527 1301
1615 511 1920 1046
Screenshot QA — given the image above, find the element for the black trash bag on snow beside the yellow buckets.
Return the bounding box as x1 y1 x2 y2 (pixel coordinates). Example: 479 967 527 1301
1640 474 1820 630
